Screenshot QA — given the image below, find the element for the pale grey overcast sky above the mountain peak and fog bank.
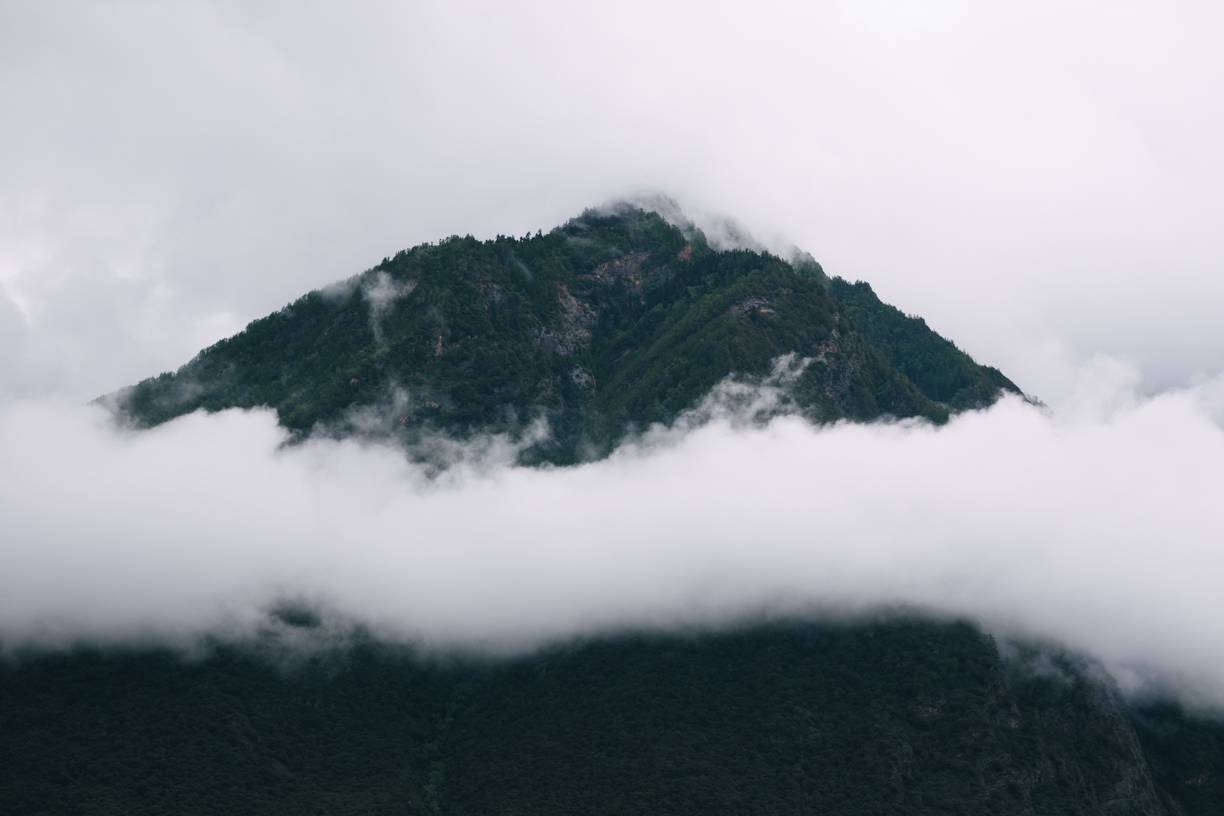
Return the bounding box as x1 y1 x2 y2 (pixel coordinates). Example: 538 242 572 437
0 1 1224 404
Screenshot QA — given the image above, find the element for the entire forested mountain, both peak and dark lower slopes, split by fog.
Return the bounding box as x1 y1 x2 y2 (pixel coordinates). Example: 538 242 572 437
16 207 1224 816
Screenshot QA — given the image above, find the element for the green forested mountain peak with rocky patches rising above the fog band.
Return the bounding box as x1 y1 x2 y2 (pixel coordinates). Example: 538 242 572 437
104 206 1020 464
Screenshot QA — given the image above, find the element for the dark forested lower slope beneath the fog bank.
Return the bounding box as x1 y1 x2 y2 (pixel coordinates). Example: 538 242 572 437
0 620 1224 816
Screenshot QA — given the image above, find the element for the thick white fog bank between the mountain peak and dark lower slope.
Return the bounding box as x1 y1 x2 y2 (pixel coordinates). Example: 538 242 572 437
0 361 1224 705
